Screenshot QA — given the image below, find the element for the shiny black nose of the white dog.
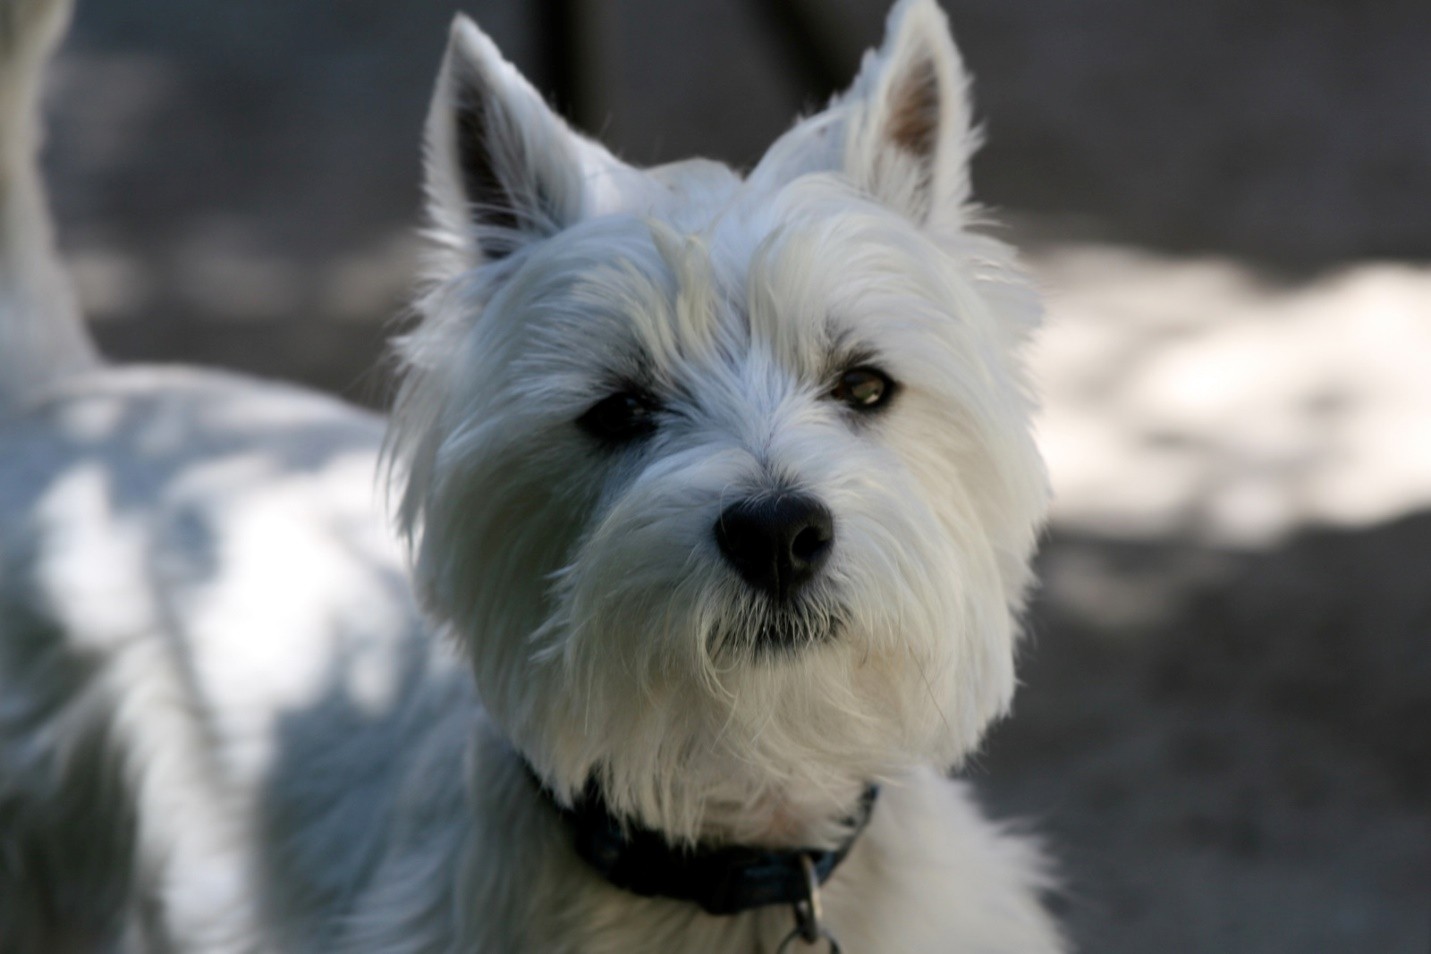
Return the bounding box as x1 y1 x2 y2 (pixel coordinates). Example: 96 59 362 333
716 495 834 599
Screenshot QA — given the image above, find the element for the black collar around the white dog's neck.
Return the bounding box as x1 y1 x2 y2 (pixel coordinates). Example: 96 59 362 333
541 782 879 914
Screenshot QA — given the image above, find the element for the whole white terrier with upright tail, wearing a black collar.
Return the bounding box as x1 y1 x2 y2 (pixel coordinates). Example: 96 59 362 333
0 0 1063 954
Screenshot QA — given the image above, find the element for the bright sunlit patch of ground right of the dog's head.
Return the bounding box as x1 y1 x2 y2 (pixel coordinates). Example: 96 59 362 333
1033 246 1431 544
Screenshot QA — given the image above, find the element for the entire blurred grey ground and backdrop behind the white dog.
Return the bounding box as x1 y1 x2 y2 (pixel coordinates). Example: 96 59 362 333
39 0 1431 954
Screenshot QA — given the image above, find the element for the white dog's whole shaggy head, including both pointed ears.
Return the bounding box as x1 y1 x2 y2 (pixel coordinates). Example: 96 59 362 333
394 0 1046 840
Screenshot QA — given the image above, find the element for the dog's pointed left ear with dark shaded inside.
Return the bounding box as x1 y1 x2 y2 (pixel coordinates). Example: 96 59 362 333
426 14 620 273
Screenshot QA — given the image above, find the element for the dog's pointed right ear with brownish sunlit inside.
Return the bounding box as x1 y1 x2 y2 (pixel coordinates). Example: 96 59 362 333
754 0 979 225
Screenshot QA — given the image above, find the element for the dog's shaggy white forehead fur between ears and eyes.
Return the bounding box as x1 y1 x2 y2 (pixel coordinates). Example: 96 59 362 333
504 160 944 389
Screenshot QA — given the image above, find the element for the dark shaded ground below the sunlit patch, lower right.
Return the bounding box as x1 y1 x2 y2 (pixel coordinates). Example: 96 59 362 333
972 513 1431 954
